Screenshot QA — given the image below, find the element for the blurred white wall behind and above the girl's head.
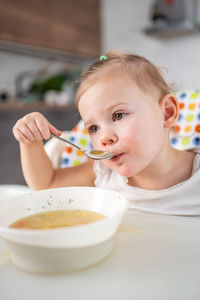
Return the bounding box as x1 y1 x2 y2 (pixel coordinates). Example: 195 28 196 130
102 0 200 89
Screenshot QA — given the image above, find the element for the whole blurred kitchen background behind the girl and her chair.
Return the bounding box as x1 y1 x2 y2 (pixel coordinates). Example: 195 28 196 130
0 0 200 184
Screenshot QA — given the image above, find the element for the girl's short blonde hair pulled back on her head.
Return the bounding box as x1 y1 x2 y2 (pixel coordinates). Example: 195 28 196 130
76 51 172 104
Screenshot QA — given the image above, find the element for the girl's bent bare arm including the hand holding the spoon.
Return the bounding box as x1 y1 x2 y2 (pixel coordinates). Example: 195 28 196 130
13 113 95 190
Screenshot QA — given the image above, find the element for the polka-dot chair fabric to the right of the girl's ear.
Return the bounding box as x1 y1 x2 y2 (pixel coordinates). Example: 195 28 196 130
170 90 200 150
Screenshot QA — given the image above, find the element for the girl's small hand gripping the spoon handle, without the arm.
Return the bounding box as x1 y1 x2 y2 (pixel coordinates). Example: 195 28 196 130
13 112 61 144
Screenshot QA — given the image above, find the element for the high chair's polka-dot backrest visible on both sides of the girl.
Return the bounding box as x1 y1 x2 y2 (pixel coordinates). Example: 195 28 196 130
45 90 200 168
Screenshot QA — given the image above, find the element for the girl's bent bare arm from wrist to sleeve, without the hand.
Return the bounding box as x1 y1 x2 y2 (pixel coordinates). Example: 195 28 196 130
20 141 95 190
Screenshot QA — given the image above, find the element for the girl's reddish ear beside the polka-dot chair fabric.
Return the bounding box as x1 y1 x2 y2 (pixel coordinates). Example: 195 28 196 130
160 94 179 128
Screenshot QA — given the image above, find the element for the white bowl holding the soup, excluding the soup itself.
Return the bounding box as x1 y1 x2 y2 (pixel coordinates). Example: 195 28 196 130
0 187 127 273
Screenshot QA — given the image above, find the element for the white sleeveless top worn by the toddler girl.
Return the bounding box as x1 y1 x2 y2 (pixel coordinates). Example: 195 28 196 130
94 153 200 216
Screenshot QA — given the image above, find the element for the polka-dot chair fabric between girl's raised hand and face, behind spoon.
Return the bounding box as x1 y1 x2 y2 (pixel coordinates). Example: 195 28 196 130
61 120 92 168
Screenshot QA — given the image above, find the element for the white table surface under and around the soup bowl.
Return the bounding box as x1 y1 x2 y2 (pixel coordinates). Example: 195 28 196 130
0 211 200 300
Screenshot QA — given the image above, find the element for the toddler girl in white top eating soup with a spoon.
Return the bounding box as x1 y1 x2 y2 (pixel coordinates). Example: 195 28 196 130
13 52 200 215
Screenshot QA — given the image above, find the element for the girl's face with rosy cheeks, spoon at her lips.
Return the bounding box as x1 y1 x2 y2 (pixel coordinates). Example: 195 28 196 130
78 76 170 177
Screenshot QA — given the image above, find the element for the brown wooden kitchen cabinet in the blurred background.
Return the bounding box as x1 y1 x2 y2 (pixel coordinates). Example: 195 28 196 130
0 0 100 58
